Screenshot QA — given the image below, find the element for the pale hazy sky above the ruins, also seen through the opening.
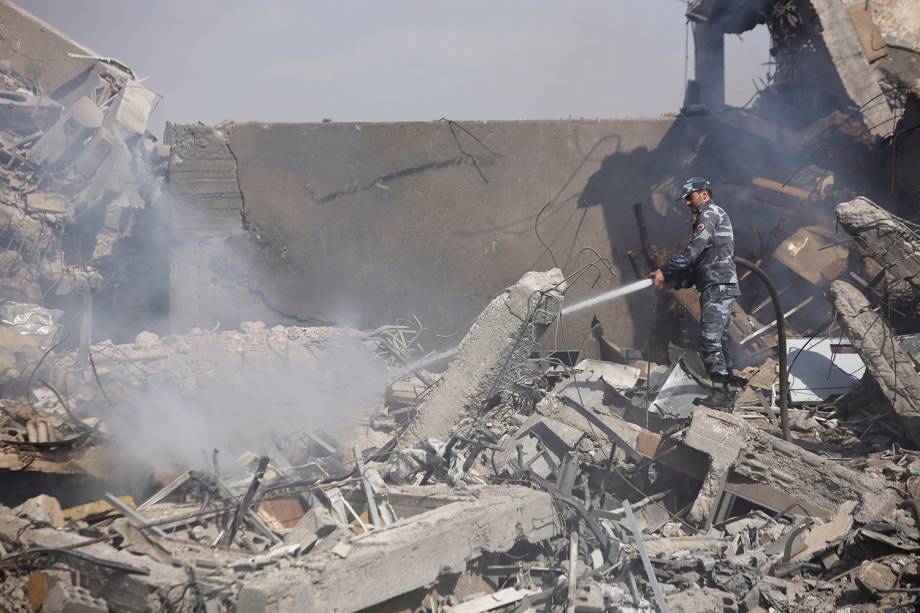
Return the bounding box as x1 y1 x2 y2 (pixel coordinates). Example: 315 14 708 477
19 0 769 136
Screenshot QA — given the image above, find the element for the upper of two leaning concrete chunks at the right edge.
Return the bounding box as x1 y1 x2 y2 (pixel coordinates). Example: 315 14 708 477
834 197 920 292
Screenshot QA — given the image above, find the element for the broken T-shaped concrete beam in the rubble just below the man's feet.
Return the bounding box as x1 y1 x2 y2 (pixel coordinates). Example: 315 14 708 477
684 408 898 524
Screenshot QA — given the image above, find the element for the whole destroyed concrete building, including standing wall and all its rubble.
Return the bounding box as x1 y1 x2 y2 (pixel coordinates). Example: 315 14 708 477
0 0 920 613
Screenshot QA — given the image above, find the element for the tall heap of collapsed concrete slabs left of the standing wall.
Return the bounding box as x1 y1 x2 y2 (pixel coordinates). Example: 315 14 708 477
0 40 169 387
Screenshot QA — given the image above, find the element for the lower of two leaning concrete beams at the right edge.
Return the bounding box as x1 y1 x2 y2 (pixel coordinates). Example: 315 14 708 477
830 281 920 444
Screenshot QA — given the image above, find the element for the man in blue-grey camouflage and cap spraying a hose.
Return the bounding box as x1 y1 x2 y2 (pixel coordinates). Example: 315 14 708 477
649 177 745 407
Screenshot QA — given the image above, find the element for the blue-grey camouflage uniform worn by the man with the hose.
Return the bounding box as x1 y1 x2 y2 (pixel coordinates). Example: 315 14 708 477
661 200 741 376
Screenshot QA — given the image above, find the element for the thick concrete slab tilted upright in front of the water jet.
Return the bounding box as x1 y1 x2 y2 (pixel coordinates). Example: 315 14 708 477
410 268 566 440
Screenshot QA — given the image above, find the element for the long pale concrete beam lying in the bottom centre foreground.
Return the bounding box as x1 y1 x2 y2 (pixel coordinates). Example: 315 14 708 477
234 485 560 613
